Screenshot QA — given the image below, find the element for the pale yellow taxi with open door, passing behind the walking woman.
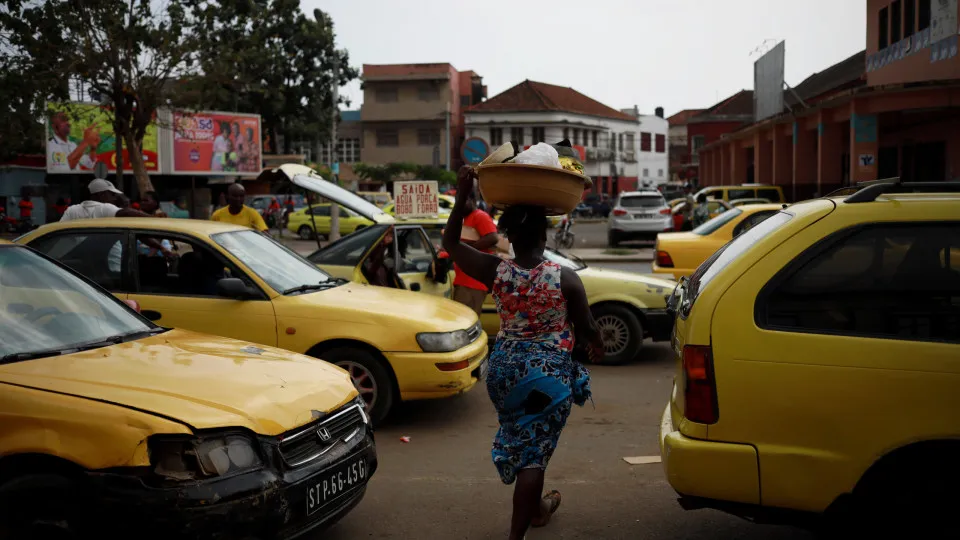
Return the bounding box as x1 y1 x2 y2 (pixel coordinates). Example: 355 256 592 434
307 219 677 364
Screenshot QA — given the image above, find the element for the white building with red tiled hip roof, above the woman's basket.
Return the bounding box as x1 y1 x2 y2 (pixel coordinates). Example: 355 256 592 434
465 80 668 195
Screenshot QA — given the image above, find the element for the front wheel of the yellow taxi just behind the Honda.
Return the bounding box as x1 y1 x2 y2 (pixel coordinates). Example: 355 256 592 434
319 348 396 426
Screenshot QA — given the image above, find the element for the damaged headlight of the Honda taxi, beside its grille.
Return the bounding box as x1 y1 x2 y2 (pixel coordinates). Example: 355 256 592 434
148 433 263 480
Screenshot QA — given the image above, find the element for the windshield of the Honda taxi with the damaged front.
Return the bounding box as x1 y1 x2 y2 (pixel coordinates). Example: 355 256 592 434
0 246 153 361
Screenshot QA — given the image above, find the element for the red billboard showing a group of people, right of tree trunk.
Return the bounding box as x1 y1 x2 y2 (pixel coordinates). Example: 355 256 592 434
173 111 262 175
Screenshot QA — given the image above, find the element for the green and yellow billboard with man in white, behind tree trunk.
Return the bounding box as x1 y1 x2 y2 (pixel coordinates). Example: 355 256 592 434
46 103 160 173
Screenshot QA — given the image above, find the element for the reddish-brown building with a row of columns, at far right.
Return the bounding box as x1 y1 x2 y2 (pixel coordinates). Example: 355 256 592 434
700 0 960 200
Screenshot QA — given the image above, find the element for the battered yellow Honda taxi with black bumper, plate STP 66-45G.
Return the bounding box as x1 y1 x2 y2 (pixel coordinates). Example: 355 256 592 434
0 240 377 538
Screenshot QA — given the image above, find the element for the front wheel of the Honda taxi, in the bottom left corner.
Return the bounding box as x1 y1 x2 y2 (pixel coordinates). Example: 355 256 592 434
0 473 84 539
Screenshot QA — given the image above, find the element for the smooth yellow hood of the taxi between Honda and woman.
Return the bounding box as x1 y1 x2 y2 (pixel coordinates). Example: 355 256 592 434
274 282 477 335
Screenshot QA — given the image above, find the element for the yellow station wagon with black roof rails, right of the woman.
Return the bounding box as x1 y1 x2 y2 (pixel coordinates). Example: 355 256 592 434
660 182 960 538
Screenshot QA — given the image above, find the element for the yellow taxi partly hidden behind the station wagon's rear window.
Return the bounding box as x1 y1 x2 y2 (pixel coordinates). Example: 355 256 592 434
653 204 783 279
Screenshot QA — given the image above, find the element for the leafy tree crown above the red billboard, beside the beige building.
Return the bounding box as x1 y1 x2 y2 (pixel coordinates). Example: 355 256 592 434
191 0 358 153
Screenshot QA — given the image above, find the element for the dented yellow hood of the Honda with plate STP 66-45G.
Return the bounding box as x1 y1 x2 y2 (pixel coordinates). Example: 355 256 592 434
0 330 357 435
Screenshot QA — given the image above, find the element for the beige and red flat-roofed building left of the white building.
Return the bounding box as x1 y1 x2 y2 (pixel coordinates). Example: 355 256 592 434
360 64 486 169
